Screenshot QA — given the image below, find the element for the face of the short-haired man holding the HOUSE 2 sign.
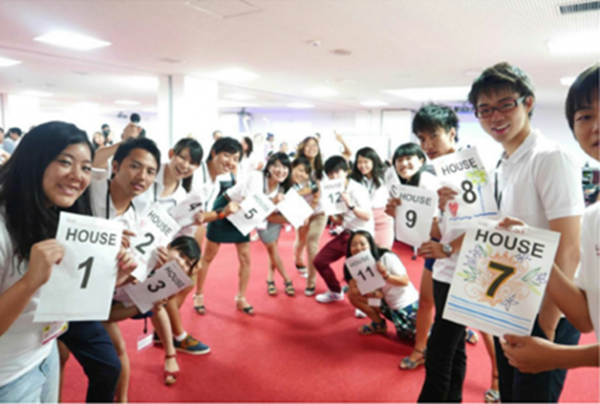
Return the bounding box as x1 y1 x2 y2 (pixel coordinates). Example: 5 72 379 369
113 149 158 197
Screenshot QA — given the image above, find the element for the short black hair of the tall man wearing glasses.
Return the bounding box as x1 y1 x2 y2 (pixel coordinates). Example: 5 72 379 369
469 62 535 118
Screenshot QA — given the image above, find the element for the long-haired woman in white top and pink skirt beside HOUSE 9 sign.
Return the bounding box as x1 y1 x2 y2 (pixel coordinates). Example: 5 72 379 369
350 147 394 249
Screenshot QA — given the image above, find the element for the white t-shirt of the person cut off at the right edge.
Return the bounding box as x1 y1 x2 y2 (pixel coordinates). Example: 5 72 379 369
575 202 600 343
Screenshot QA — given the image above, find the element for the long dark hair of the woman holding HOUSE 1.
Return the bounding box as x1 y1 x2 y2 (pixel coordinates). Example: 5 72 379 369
0 122 94 259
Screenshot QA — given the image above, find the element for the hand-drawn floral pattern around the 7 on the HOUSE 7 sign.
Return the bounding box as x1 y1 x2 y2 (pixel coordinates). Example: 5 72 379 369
458 244 548 311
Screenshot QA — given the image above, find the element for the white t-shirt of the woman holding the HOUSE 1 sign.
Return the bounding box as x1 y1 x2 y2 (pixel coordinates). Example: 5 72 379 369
0 213 55 386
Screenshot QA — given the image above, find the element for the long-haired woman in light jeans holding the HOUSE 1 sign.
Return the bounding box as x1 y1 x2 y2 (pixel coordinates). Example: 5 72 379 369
0 122 119 402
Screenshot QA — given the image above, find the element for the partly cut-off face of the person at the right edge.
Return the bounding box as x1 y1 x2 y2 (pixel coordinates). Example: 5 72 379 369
573 92 600 161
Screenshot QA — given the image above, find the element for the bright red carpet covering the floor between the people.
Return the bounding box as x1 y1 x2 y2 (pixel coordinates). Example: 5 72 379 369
63 232 600 403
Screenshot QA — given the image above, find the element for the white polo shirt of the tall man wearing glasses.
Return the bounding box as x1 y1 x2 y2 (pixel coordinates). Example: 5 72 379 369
494 131 585 229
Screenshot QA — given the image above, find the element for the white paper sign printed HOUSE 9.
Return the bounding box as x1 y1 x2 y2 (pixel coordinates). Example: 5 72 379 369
395 185 438 247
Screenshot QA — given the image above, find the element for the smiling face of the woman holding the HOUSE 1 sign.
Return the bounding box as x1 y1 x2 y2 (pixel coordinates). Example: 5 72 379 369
42 143 92 208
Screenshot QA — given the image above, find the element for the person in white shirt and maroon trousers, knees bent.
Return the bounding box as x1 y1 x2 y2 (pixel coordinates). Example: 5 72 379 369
315 156 375 303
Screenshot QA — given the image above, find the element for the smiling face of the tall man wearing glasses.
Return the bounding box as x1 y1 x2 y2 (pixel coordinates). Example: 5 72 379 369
477 90 533 152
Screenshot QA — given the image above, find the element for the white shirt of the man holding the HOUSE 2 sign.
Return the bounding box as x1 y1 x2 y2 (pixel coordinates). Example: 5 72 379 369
89 169 138 229
